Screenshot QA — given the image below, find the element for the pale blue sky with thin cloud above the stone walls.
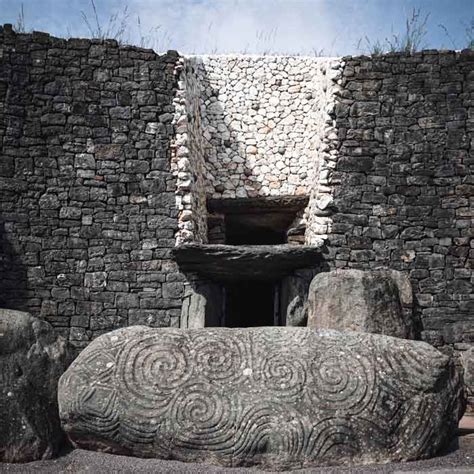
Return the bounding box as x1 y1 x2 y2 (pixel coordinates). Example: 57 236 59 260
0 0 474 56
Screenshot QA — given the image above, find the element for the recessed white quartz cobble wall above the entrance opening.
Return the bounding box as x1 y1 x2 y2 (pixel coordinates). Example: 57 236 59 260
174 55 341 244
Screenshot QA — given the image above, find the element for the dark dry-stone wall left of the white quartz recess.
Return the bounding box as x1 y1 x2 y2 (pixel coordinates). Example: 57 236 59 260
0 27 184 347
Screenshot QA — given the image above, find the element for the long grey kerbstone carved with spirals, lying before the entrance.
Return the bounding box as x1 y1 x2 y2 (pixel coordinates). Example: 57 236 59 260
59 326 463 469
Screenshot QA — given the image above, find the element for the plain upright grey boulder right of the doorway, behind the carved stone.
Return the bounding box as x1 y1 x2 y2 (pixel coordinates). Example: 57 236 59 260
308 270 413 339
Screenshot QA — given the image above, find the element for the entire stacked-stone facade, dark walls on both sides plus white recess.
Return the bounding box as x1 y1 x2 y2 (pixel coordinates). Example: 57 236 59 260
0 28 474 360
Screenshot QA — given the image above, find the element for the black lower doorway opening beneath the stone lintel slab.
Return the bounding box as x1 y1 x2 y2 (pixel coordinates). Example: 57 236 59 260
223 281 279 328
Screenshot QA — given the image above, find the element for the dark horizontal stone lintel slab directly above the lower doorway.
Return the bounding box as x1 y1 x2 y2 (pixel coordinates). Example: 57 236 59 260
173 244 323 281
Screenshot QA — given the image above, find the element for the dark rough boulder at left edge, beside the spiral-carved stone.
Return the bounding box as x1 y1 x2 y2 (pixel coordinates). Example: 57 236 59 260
0 309 68 462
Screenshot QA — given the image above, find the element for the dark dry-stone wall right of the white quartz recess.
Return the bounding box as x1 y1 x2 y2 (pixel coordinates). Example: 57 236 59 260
323 51 474 356
